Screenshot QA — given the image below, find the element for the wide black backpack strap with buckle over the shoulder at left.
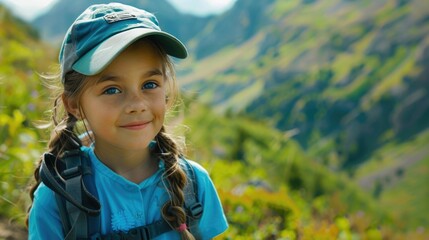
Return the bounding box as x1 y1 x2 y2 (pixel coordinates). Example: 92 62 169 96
40 149 101 240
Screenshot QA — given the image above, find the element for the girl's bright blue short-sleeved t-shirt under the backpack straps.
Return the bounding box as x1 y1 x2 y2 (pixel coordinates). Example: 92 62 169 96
29 147 228 240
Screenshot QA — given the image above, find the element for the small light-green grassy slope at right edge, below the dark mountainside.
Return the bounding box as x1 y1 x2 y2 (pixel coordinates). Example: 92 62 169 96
355 131 429 231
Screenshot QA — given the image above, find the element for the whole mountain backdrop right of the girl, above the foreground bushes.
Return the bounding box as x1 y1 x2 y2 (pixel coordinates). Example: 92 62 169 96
175 0 429 232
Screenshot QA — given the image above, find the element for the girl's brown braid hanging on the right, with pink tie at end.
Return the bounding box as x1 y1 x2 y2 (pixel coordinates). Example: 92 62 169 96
157 127 195 240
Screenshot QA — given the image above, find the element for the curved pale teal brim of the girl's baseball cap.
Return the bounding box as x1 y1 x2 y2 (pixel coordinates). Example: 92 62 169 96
72 28 188 76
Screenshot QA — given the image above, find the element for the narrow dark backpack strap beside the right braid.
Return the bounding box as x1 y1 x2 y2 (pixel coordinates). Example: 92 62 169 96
180 158 203 239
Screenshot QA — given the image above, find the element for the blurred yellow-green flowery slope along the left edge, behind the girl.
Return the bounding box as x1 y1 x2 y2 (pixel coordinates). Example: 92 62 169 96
0 5 54 227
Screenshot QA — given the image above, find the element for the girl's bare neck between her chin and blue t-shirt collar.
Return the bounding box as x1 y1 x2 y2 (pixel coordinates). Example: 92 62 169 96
94 146 158 184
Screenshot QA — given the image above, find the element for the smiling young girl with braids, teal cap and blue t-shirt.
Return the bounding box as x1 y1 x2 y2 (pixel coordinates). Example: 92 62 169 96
28 3 228 239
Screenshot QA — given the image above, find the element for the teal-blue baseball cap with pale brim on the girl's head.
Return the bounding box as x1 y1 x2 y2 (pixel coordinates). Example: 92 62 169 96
59 3 188 83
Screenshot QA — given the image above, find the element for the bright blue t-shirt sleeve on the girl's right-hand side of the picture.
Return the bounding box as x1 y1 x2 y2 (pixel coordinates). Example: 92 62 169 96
189 161 228 239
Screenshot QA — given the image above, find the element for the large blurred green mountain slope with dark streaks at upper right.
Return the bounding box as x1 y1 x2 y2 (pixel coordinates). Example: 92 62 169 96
181 0 429 168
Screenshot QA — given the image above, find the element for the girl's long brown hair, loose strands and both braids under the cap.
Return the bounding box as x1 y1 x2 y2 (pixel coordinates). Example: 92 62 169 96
27 38 195 240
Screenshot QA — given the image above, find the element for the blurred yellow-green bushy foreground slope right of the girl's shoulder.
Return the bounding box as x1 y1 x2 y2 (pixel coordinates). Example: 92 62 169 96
178 101 429 239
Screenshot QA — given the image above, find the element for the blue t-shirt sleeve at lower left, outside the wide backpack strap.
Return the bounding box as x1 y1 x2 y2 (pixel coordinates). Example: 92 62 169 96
28 183 64 240
